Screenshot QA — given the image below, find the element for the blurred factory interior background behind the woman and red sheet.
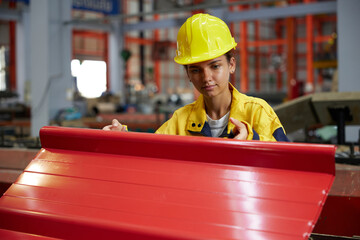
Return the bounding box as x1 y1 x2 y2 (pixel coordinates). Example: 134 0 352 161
0 0 360 240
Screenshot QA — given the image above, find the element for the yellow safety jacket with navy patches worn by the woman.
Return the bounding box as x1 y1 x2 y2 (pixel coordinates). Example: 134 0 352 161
155 83 289 141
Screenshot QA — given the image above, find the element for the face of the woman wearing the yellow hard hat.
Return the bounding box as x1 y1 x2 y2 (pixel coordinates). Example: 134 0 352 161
186 55 235 97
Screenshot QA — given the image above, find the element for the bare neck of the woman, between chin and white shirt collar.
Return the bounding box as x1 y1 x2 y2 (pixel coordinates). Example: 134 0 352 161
204 89 232 120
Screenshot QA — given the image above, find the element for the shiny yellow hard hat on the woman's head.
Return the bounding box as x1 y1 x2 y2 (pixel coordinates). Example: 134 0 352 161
174 13 237 65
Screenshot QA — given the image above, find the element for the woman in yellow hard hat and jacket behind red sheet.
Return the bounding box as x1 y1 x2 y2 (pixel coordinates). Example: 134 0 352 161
103 14 288 141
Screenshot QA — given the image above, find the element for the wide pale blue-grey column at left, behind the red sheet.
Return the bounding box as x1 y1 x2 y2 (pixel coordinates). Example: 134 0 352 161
29 0 72 136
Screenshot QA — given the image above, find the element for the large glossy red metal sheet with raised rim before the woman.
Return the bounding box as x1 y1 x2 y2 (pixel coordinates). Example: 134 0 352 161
0 127 335 239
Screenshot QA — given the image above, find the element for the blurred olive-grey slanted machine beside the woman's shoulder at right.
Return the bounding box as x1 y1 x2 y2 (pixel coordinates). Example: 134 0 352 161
274 92 360 164
